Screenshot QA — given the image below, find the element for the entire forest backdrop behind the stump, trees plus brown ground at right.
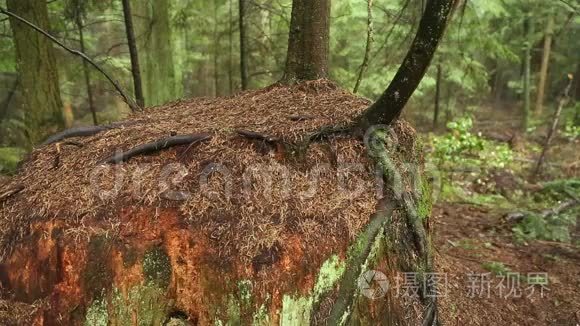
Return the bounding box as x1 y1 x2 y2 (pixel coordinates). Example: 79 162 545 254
0 0 580 324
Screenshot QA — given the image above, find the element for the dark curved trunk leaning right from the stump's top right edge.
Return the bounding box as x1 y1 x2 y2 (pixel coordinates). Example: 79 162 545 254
357 0 456 133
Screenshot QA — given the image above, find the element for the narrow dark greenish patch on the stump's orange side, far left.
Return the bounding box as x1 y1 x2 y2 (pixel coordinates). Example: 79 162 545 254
83 236 112 299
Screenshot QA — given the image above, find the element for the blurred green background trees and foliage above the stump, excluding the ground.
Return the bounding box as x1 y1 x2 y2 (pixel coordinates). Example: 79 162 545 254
0 0 580 155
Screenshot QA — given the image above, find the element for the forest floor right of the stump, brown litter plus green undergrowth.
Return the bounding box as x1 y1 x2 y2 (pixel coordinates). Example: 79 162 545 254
414 105 580 326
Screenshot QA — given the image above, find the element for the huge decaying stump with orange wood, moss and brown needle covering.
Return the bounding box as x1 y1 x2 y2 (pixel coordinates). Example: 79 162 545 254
0 81 435 325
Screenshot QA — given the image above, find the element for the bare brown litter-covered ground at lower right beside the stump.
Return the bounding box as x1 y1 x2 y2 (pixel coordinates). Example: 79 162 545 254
433 203 580 326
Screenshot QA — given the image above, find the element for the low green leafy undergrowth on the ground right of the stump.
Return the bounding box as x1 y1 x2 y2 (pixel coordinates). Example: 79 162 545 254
429 116 580 243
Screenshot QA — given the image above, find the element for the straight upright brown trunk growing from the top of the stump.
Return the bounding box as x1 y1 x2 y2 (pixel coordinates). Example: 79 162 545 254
282 0 330 83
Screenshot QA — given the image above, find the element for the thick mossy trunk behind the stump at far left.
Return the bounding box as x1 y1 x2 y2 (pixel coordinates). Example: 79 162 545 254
6 0 64 145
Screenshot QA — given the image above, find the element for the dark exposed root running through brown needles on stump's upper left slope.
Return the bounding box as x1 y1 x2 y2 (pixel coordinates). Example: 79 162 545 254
99 133 211 164
